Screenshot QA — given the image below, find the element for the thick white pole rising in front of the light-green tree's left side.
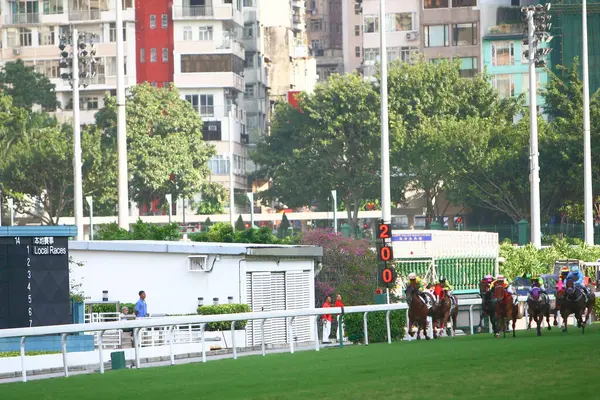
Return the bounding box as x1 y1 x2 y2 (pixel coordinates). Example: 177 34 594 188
115 0 129 230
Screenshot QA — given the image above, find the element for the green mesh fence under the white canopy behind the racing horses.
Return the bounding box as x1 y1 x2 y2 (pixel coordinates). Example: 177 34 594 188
396 257 496 294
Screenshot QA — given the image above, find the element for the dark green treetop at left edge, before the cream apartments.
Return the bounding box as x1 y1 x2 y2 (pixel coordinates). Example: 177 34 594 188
0 59 58 110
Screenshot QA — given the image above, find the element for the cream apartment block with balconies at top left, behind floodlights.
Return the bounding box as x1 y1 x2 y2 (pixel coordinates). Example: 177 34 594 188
0 0 136 124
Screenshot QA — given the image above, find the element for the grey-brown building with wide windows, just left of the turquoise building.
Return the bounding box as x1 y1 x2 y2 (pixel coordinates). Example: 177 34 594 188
421 0 481 77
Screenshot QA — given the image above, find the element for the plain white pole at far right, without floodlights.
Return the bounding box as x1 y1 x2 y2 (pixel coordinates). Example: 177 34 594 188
581 0 594 246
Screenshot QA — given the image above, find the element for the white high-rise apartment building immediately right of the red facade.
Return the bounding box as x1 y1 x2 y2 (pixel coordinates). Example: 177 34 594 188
171 0 249 190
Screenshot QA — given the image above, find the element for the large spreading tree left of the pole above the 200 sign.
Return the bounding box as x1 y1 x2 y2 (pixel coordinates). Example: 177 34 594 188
252 74 380 233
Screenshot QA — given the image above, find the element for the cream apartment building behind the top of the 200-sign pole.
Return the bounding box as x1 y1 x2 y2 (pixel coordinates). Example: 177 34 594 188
354 0 420 77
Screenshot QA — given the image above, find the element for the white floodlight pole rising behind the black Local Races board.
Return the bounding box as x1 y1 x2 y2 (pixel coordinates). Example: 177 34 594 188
71 28 83 240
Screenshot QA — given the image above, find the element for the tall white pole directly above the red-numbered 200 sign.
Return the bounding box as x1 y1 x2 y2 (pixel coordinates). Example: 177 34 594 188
379 0 392 224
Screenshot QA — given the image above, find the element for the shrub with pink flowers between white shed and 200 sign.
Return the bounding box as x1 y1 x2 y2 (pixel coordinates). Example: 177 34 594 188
302 229 377 306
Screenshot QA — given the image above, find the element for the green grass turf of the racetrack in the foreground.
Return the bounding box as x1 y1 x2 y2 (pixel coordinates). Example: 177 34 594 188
0 325 600 400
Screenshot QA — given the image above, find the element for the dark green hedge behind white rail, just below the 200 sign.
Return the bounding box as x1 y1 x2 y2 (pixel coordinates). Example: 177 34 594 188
344 310 406 343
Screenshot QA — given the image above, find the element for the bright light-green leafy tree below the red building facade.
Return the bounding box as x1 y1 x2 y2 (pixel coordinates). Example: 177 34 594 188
96 84 215 209
